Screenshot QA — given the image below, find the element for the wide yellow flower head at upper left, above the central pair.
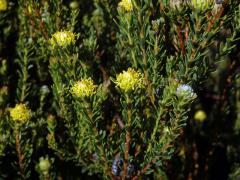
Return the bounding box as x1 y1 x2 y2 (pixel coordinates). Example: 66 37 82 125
50 31 76 47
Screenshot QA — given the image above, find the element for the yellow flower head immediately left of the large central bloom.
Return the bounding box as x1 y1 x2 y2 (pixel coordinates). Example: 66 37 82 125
71 78 97 97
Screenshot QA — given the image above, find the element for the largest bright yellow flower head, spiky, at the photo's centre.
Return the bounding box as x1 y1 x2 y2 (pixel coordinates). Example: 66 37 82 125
115 68 143 92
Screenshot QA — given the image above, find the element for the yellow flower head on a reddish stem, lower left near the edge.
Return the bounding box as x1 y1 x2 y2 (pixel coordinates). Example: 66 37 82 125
10 103 31 123
